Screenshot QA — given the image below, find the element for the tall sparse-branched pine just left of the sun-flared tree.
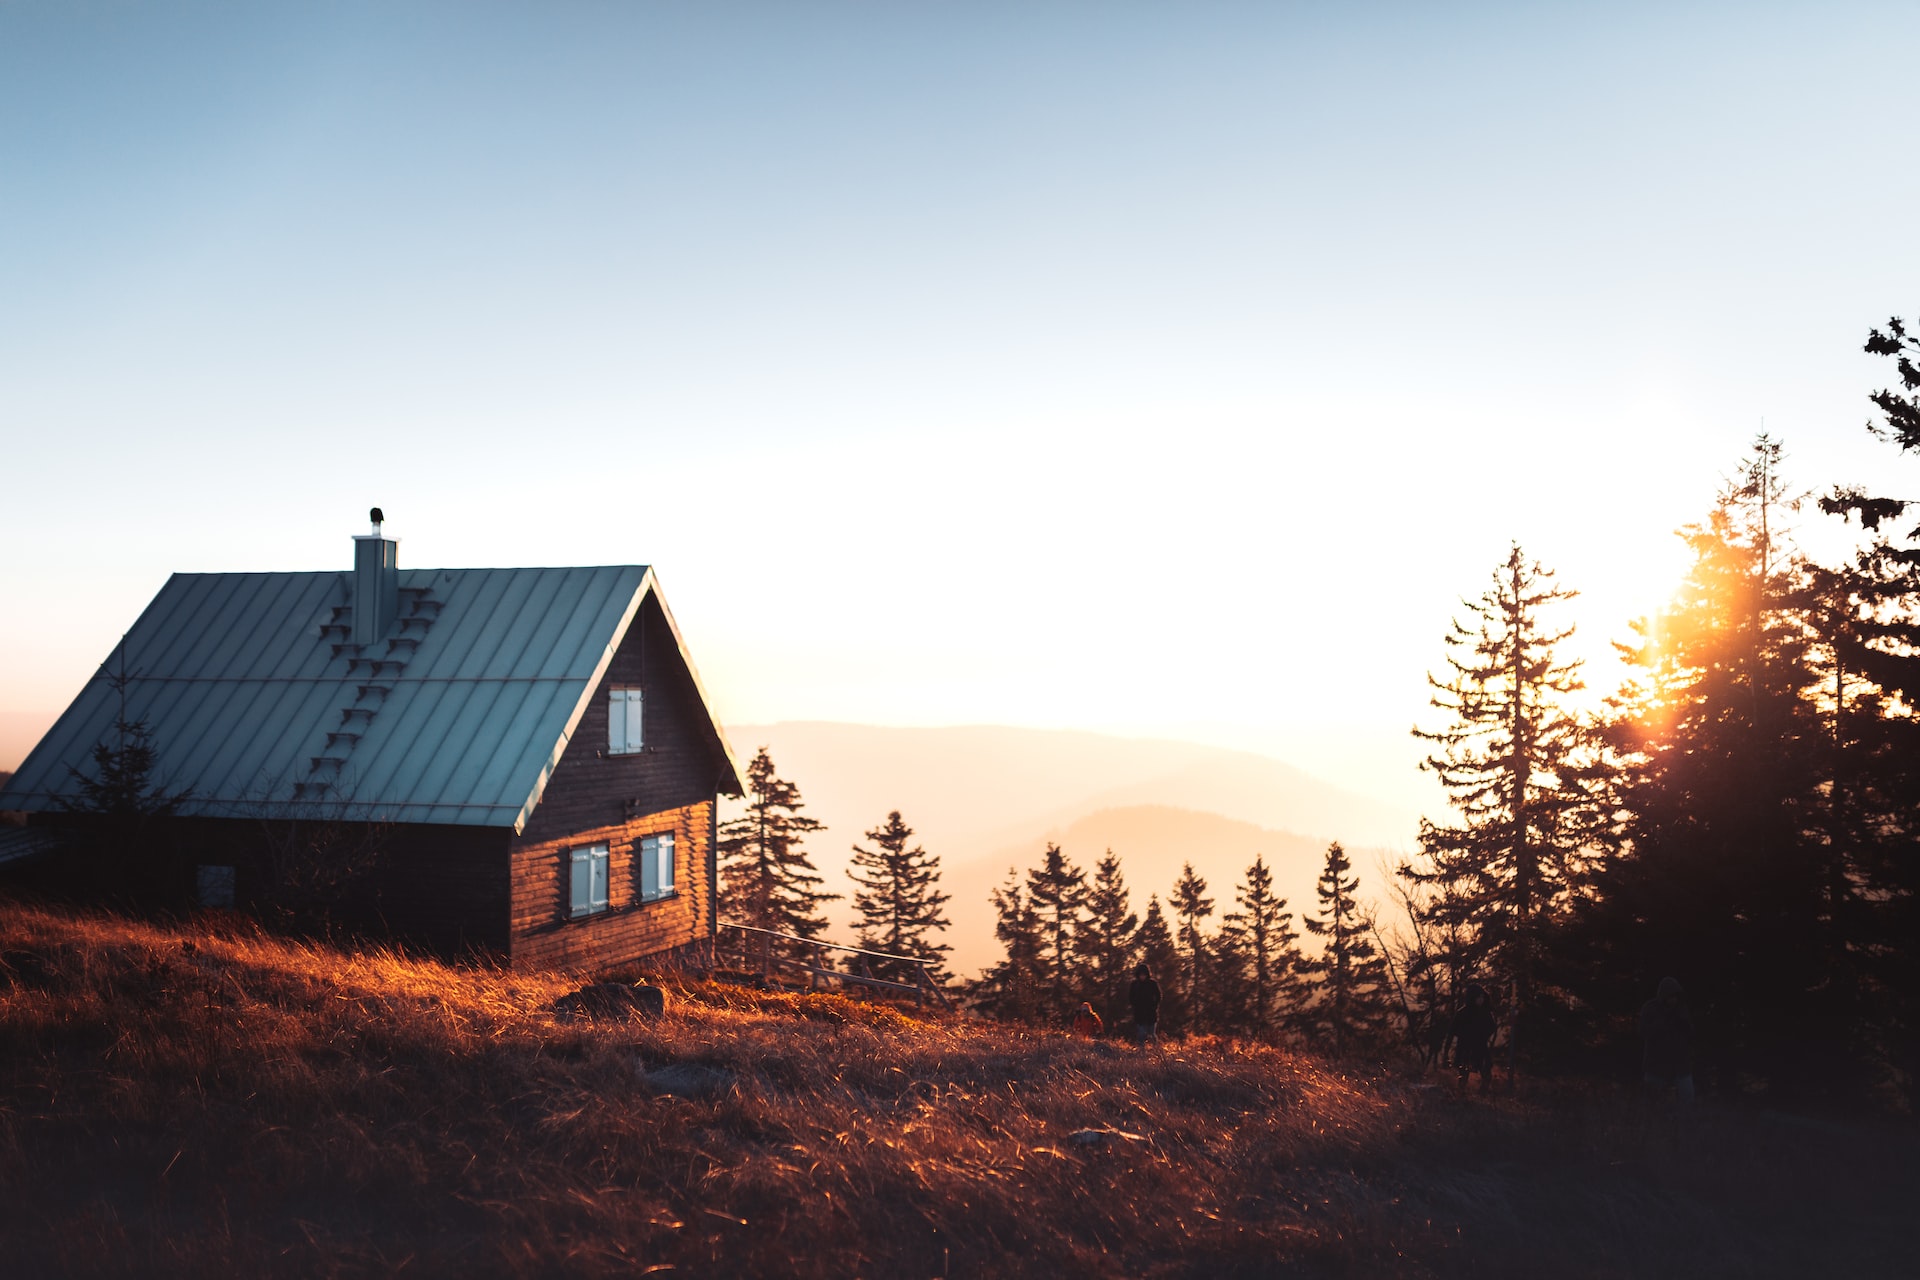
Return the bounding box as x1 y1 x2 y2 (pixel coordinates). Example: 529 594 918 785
1402 545 1599 1080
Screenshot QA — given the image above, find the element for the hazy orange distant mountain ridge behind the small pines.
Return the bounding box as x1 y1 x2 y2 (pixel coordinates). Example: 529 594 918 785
728 722 1417 975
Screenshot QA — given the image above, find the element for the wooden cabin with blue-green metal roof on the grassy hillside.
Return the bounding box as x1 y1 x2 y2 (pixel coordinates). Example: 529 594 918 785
0 509 741 969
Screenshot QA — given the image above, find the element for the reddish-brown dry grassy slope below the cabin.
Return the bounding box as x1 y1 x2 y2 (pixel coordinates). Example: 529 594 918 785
0 904 1920 1276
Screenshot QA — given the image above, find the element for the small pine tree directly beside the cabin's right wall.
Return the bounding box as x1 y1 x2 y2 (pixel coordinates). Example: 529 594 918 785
720 747 839 950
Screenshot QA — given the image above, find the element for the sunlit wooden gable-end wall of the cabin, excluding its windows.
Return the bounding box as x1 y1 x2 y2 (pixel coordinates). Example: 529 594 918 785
509 599 720 969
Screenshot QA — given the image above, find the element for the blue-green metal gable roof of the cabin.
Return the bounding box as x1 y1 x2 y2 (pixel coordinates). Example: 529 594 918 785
0 564 741 831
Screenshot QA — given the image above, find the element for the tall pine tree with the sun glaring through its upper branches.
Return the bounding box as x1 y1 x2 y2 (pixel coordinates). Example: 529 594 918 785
1563 436 1870 1096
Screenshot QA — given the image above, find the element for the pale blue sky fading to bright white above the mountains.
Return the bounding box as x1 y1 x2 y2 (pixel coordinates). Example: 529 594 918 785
0 0 1920 798
